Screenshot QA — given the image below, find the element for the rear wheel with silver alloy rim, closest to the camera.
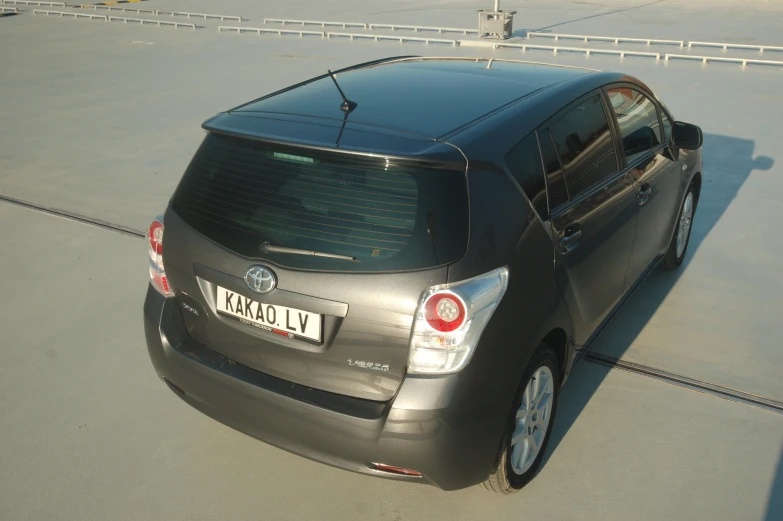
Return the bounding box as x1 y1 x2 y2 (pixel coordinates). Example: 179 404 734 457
484 344 560 494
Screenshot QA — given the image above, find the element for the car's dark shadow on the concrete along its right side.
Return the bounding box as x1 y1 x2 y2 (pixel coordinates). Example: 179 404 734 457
544 134 783 466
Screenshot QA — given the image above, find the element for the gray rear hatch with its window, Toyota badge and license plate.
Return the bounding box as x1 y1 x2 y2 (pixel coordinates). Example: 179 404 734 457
163 118 469 401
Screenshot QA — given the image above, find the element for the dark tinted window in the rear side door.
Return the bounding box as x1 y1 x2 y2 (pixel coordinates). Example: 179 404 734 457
549 94 618 199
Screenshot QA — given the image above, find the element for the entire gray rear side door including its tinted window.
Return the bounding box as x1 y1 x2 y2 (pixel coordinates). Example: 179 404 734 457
539 93 637 345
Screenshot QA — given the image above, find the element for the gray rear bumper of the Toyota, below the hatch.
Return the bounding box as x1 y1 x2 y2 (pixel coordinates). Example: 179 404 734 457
144 287 508 490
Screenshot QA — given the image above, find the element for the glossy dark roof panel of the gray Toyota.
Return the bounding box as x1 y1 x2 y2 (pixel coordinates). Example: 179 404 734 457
229 57 596 138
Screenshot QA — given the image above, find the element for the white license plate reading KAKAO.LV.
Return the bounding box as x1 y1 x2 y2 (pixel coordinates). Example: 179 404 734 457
216 286 321 342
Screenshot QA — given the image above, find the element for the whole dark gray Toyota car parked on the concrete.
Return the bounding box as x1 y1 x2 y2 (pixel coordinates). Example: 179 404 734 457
144 57 702 493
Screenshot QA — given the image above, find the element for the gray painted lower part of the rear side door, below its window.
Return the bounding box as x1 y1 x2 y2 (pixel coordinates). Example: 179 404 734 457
551 174 637 345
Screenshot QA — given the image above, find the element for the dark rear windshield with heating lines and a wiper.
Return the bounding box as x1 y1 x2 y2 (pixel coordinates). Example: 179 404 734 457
172 134 468 272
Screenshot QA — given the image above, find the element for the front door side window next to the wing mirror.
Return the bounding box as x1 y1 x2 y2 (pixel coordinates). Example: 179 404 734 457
606 87 662 164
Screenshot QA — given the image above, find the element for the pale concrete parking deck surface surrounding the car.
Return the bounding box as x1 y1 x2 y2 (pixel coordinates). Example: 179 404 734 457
0 0 783 521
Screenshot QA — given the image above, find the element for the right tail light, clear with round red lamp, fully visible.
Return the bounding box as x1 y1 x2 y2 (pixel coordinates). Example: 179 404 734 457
408 267 508 374
